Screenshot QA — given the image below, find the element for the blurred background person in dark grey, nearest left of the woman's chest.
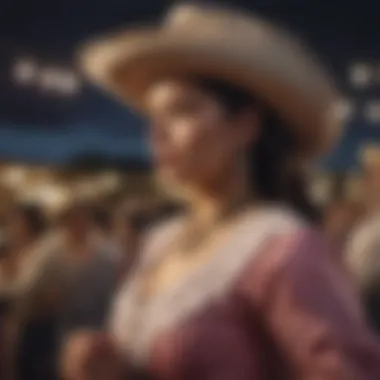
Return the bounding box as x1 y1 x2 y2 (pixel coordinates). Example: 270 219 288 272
56 201 120 337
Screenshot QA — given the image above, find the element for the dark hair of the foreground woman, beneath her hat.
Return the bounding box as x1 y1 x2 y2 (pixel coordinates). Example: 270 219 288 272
192 77 319 221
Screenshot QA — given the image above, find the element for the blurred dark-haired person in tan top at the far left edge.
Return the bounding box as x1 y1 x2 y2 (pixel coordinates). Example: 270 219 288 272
0 203 56 379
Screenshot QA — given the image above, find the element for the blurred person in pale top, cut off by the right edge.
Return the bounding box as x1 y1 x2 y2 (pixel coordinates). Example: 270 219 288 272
347 145 380 332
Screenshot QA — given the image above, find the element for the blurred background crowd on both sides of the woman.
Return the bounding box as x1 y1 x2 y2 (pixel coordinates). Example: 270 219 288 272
0 155 380 380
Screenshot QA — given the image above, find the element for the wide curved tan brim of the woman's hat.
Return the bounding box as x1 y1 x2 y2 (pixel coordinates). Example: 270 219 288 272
80 28 342 156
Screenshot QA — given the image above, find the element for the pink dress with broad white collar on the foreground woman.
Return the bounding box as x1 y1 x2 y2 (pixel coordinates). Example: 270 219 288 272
110 208 380 380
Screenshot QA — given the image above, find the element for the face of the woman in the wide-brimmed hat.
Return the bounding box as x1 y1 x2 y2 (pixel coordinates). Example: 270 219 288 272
146 80 255 191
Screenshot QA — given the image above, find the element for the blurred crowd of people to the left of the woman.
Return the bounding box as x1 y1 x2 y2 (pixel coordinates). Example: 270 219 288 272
0 196 177 380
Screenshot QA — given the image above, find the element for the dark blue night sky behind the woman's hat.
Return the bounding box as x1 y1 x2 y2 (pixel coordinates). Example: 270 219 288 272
0 0 380 167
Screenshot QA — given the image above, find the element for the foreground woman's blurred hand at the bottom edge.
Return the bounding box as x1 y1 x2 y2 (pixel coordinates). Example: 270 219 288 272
61 331 125 380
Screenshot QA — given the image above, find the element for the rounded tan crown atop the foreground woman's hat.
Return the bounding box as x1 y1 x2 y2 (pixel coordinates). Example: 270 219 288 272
162 3 313 64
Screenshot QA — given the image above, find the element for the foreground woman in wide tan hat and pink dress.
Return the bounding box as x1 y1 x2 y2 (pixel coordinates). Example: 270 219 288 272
61 4 380 380
